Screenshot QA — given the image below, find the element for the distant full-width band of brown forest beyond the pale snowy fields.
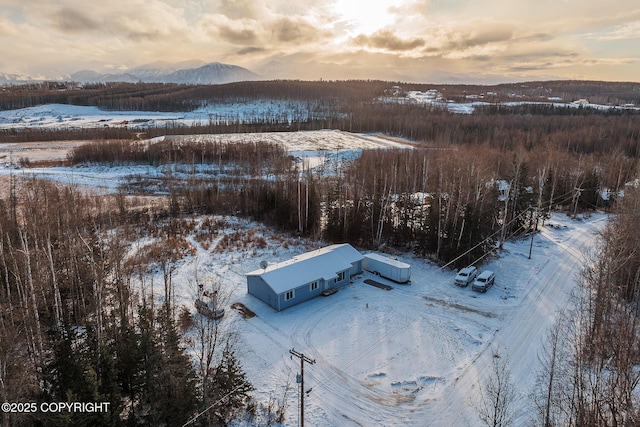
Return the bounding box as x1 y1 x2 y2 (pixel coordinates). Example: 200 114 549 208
0 103 640 157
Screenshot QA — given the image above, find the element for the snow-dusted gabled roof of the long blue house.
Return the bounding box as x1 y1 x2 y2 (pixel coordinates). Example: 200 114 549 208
247 243 363 294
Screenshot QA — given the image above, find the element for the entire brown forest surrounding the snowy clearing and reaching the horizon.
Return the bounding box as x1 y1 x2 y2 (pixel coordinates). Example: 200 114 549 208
0 81 640 426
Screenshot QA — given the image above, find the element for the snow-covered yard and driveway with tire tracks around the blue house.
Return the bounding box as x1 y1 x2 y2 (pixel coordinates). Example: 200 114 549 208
134 214 606 427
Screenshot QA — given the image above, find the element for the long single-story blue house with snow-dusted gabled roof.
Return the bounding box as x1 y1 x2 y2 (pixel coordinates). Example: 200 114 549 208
247 243 364 311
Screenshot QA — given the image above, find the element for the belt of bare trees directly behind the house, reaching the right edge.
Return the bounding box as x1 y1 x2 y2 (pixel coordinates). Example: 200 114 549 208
65 138 637 266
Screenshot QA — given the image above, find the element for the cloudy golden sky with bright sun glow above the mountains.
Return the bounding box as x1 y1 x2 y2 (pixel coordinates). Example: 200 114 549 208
0 0 640 83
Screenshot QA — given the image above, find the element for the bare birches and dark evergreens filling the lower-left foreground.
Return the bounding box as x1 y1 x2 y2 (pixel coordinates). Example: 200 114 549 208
0 181 251 426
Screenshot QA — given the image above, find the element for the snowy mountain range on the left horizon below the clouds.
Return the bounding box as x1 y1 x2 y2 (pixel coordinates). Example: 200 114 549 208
0 61 260 85
